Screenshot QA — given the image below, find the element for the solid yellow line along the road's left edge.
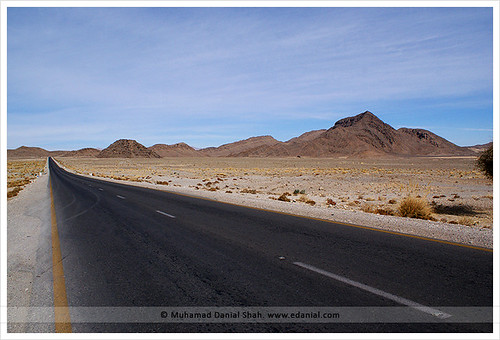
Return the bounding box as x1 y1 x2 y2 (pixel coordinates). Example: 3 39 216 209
49 179 71 333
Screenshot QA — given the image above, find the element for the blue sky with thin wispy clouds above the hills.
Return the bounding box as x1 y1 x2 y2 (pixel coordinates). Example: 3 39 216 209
7 8 493 150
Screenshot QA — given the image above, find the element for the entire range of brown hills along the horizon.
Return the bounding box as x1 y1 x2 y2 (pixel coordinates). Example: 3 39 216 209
8 111 482 158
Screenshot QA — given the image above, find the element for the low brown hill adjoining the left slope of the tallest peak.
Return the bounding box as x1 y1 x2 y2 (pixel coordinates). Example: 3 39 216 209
200 136 282 157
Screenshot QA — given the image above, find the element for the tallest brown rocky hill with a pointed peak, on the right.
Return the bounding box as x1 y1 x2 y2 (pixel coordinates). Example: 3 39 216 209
232 111 473 157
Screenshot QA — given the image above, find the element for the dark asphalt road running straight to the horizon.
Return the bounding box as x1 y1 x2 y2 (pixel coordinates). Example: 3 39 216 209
49 159 493 332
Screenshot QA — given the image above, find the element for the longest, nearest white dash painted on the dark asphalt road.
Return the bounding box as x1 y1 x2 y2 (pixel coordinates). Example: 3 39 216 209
293 262 451 319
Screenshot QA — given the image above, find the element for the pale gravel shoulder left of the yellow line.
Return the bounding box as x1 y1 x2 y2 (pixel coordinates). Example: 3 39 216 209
7 170 53 333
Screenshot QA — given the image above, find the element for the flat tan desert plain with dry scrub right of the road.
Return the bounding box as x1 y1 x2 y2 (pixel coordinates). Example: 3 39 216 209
57 157 493 229
